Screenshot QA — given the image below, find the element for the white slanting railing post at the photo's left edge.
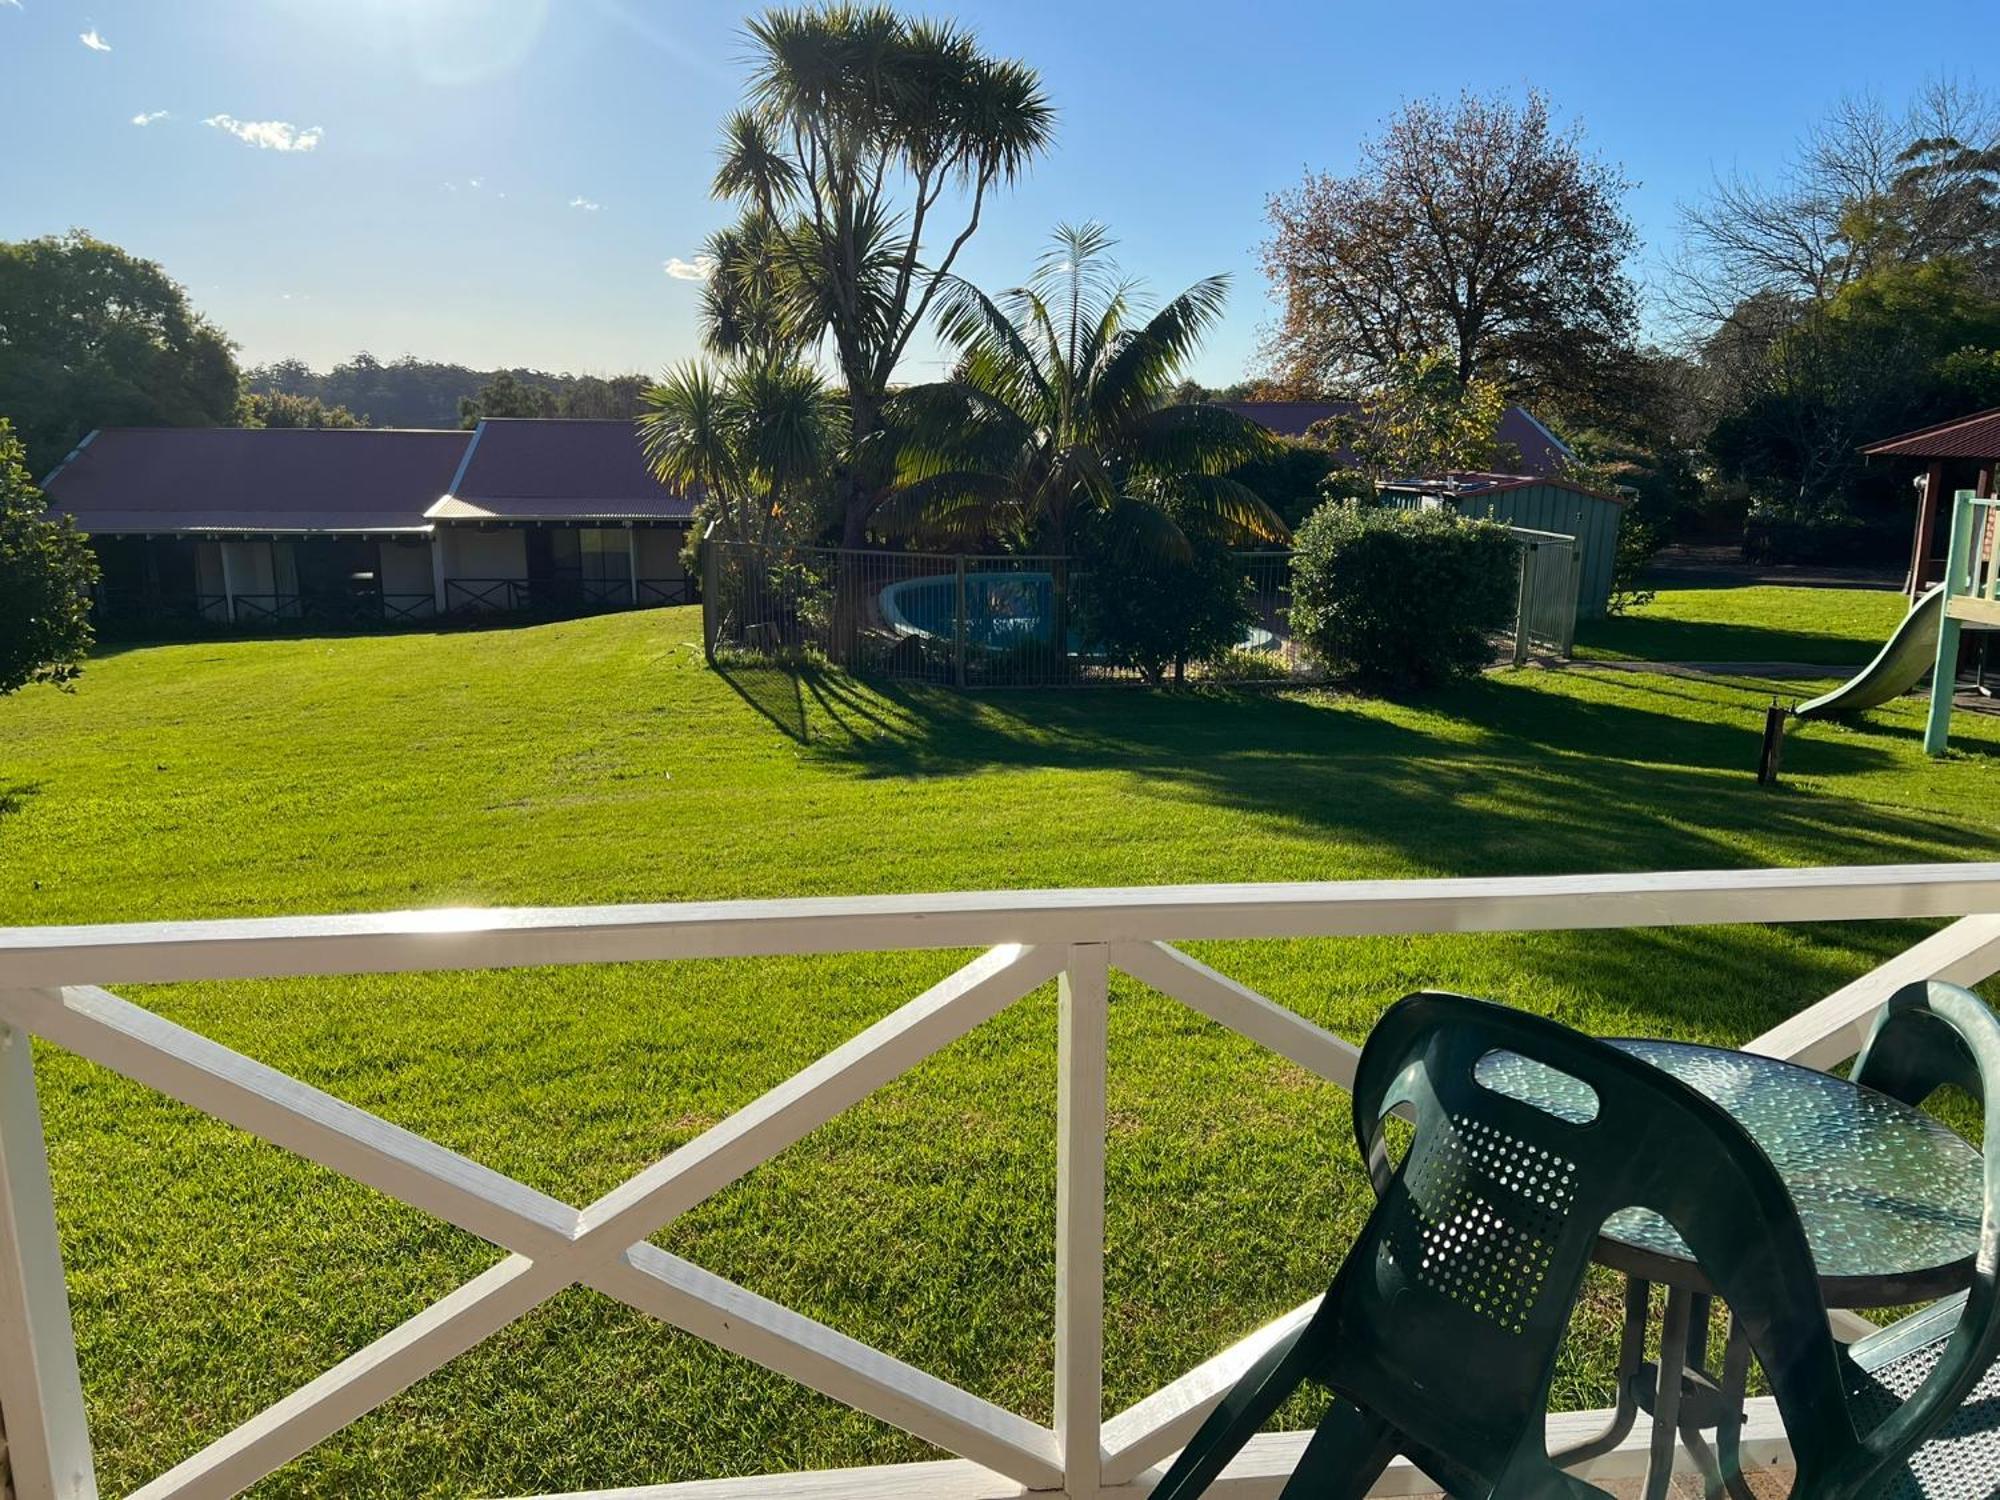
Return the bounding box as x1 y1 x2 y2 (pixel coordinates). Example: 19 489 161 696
0 1026 98 1500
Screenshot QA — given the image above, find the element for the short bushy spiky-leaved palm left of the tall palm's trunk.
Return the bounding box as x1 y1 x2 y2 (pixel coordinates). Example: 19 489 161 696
638 358 844 546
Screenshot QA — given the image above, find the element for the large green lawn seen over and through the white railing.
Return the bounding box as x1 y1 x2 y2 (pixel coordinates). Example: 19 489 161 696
0 604 2000 1496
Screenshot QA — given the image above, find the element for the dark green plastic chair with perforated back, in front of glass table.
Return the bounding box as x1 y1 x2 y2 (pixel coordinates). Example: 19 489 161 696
1154 994 1984 1500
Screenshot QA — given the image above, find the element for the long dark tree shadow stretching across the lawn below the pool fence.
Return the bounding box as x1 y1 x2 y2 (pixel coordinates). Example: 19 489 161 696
712 666 2000 876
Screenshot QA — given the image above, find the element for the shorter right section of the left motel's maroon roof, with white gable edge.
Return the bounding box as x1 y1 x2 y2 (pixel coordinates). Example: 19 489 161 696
430 416 694 520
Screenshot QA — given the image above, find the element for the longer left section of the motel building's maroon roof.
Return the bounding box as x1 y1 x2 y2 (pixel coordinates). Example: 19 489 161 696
42 428 470 534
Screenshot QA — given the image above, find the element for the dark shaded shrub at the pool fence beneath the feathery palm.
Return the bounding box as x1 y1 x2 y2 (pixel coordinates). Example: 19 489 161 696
1070 538 1254 686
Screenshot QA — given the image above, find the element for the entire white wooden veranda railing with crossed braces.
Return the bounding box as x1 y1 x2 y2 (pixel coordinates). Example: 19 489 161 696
0 864 2000 1500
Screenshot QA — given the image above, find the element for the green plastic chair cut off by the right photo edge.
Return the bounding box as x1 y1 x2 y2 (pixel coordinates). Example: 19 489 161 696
1848 980 2000 1500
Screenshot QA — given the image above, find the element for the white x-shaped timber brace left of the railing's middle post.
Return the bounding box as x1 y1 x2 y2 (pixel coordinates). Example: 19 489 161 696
0 946 1064 1500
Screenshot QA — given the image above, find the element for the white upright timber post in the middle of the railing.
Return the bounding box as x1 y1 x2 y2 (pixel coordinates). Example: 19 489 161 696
1056 942 1110 1500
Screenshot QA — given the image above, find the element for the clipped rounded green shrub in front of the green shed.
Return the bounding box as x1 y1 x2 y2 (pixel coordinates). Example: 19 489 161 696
1292 504 1520 688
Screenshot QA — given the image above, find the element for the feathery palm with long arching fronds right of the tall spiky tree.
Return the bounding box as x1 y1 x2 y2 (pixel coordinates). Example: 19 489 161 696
882 224 1286 556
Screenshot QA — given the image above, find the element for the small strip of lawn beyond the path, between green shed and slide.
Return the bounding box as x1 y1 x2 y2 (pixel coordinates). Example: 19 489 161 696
1576 584 1908 668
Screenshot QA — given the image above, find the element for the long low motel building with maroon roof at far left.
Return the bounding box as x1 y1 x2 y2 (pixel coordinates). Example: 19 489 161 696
42 418 692 634
